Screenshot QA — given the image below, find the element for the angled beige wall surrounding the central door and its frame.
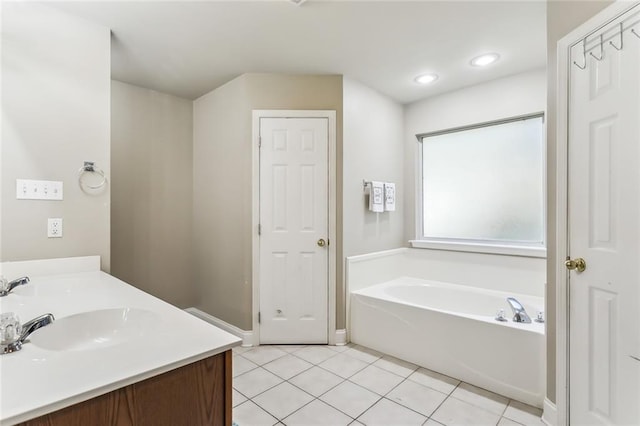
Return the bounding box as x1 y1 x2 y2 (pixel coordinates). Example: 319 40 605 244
193 74 344 330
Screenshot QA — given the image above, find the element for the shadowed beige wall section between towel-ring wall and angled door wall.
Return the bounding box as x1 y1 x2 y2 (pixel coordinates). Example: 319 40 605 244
111 80 195 308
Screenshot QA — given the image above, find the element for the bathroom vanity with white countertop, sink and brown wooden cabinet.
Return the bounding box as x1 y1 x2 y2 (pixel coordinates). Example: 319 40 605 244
0 257 241 425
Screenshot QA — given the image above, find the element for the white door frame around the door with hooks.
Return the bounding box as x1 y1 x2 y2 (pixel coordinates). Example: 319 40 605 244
556 1 638 426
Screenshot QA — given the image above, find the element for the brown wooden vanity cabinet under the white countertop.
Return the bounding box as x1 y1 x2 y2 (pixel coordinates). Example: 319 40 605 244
21 350 233 426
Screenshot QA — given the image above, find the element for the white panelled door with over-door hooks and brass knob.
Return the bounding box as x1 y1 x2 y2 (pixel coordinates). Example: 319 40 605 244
568 12 640 425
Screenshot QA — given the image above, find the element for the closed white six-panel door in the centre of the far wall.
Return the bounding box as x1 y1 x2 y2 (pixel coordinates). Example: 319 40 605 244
260 118 329 344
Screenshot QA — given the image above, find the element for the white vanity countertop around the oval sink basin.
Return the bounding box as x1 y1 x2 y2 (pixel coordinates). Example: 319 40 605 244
0 258 241 425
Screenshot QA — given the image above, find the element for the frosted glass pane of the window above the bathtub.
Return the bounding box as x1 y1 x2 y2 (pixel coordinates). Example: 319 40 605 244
422 116 545 246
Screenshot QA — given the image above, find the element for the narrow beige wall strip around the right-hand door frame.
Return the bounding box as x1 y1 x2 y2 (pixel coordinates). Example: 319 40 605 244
546 1 612 403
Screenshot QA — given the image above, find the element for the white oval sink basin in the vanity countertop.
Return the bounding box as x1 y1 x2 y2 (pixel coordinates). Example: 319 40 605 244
27 308 159 351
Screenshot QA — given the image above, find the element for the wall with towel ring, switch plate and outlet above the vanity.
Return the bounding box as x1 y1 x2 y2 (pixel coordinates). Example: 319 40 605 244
0 2 111 271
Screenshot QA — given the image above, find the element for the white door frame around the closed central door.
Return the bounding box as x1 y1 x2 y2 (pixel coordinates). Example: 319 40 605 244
251 110 337 346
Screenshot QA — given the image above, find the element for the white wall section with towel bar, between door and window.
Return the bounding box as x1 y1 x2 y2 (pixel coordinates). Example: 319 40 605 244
342 78 406 257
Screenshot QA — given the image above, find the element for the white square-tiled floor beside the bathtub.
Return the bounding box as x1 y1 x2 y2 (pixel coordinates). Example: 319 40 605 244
233 345 543 426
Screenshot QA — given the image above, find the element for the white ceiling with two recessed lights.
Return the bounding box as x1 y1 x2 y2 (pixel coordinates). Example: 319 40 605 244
48 0 546 103
